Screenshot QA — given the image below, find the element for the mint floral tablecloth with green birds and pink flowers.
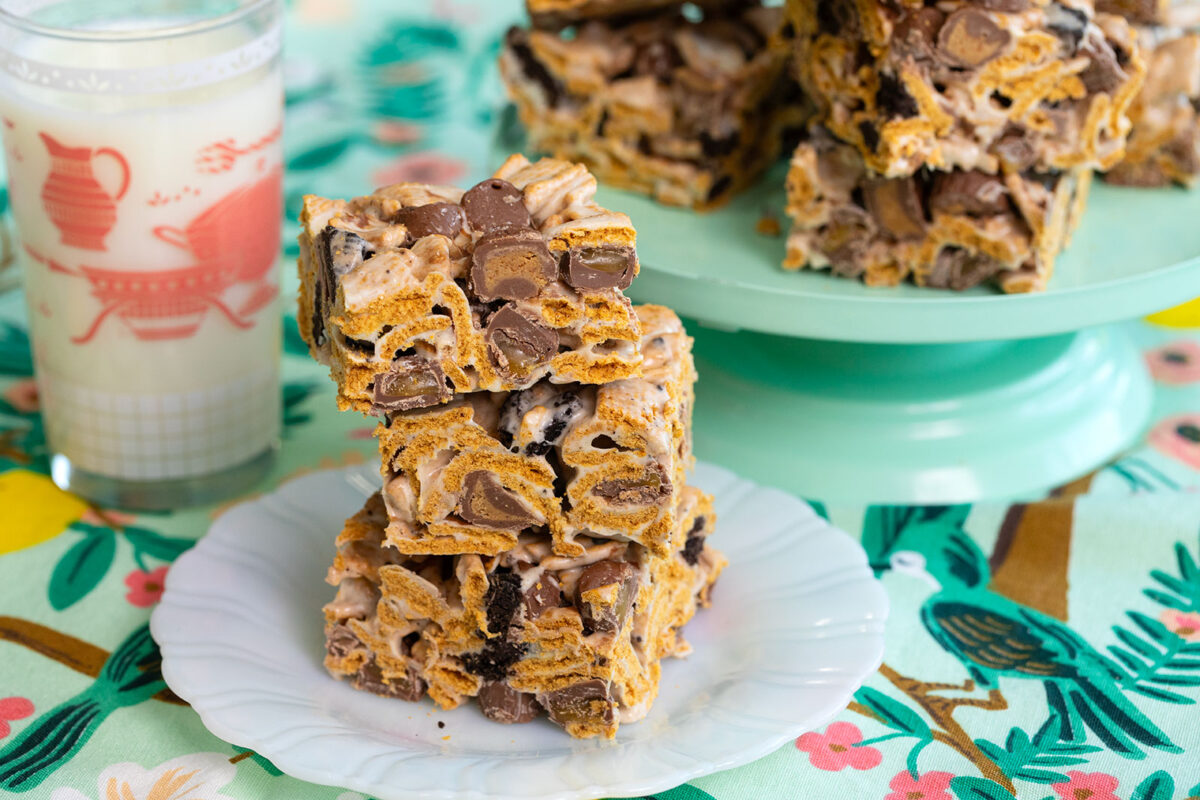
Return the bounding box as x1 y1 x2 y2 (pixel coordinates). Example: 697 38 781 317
0 0 1200 800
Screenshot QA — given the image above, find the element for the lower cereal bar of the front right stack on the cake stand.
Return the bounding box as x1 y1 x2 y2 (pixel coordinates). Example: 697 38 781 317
784 126 1091 293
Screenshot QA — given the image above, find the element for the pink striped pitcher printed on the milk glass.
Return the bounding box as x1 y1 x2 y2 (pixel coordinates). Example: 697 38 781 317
38 132 130 251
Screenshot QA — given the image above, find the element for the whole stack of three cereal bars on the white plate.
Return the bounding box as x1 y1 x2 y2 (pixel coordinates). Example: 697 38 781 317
300 151 725 738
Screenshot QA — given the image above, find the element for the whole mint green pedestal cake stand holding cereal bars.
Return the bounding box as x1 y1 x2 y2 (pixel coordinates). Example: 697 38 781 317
600 172 1200 504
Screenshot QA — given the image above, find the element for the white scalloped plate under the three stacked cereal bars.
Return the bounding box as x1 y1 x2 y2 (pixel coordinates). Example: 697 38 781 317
150 464 887 800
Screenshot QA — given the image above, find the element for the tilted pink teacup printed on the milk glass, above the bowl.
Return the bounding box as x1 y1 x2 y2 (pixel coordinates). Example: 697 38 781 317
154 169 283 283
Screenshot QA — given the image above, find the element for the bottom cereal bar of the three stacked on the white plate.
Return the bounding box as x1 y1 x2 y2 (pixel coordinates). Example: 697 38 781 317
325 487 725 738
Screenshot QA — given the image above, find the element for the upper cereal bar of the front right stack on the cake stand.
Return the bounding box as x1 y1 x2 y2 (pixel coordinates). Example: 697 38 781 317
787 0 1145 178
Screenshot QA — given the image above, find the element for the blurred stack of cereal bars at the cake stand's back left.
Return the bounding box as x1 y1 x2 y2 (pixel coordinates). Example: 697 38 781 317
500 0 804 209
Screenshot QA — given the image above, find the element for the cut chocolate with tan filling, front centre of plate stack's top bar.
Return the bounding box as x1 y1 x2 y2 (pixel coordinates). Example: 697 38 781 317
470 230 558 302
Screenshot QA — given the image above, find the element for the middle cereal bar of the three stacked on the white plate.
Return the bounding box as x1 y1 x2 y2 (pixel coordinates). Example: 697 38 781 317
376 306 696 557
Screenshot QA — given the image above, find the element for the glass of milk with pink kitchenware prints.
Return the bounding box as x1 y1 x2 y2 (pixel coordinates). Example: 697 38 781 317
0 0 283 509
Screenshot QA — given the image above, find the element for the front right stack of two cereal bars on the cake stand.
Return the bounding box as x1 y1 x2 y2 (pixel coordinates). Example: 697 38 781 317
785 0 1147 291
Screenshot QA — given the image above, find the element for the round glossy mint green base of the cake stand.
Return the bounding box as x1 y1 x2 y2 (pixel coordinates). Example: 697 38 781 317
689 324 1152 504
